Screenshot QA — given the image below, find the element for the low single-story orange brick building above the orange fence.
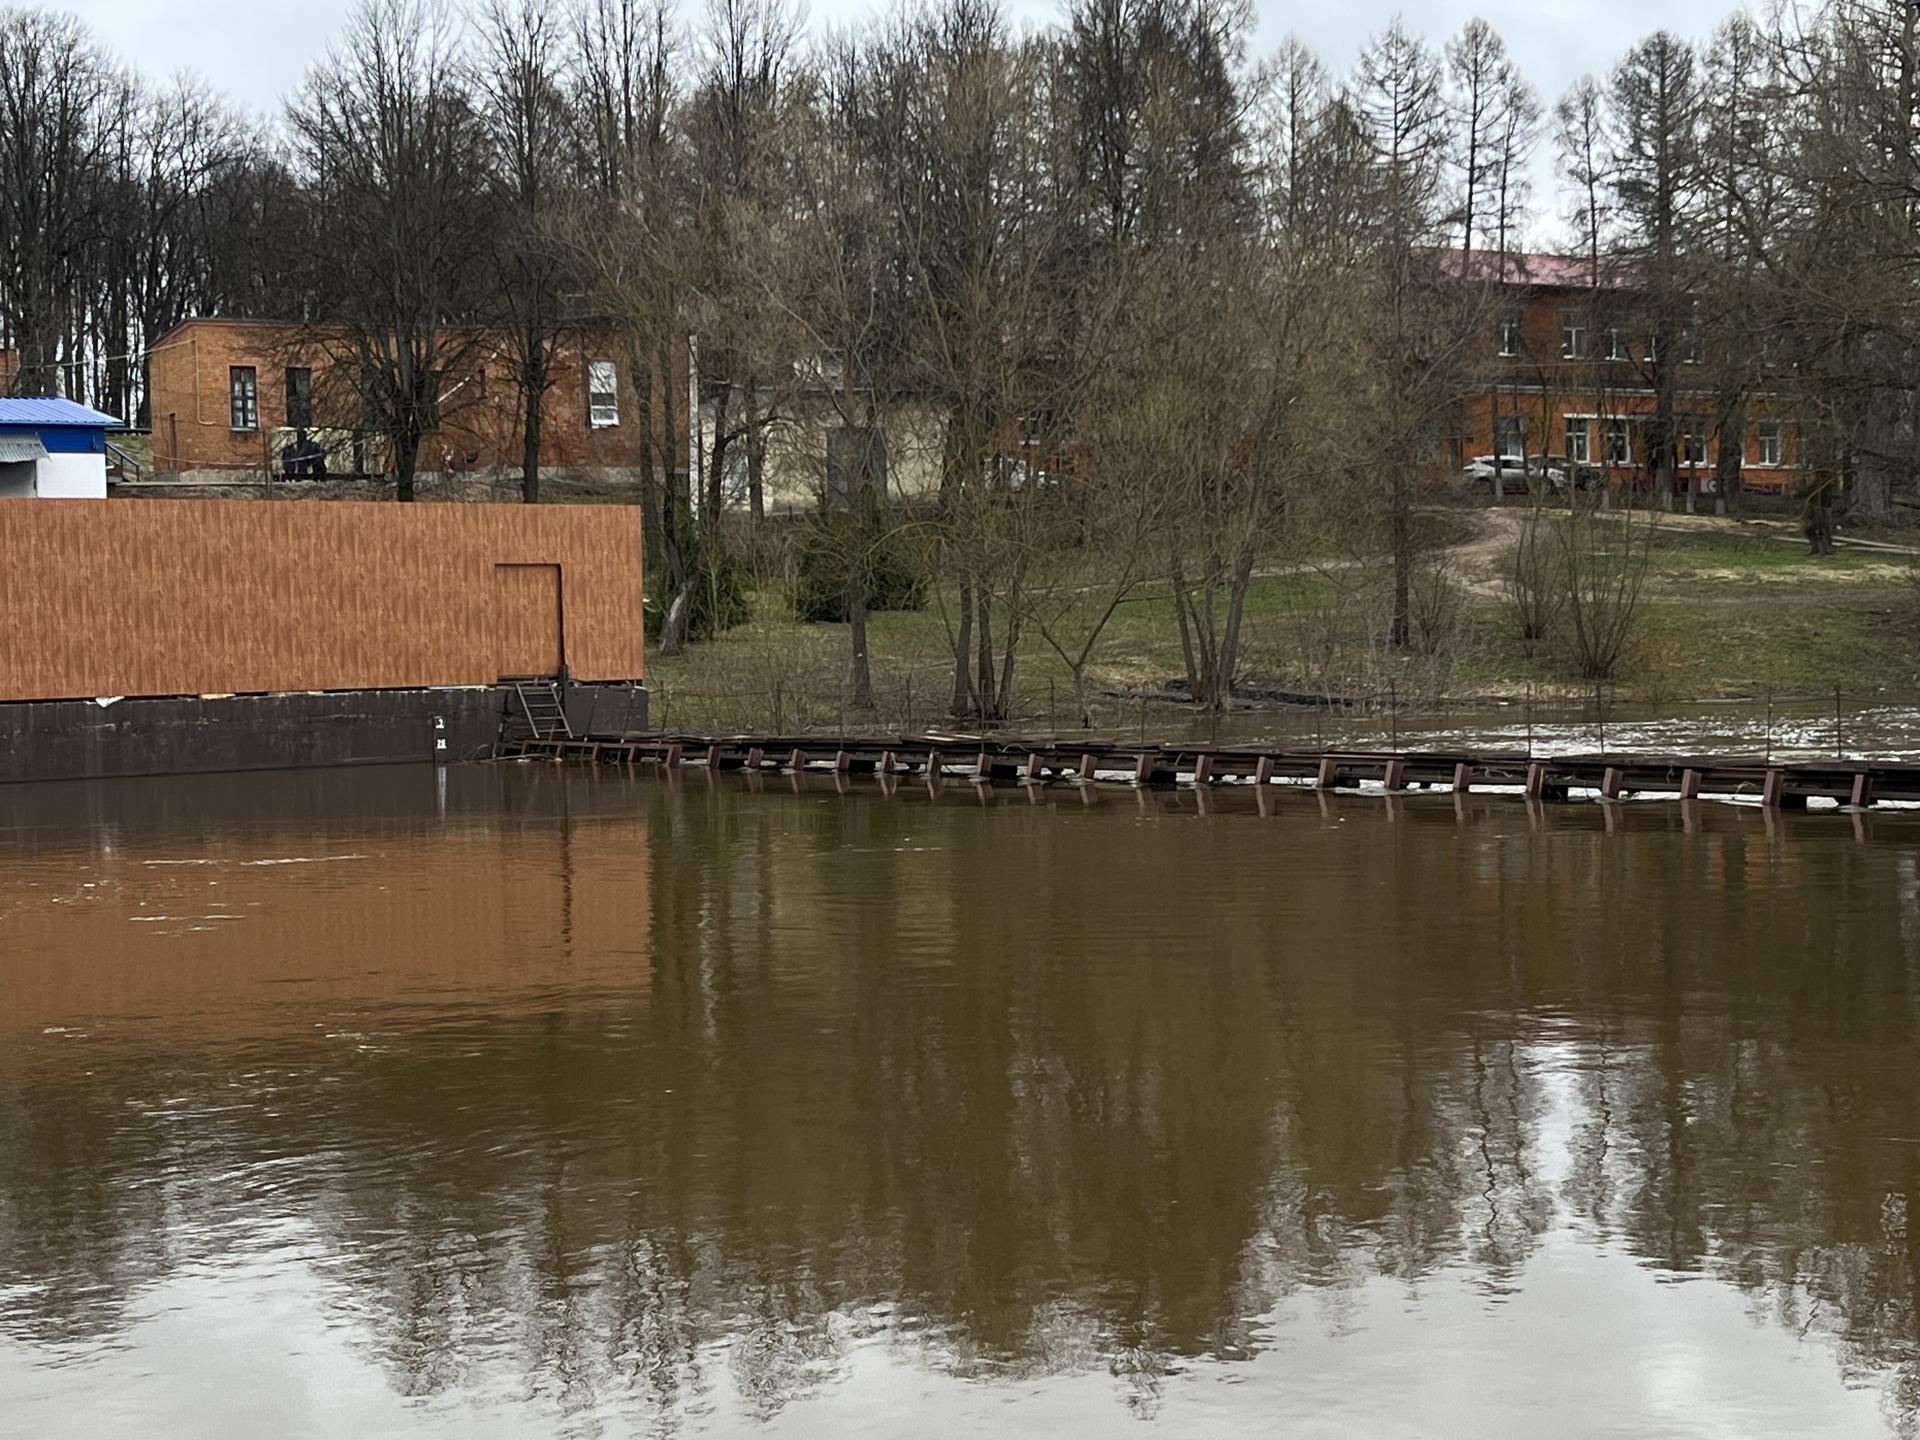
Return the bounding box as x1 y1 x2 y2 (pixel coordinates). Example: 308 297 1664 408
148 319 668 474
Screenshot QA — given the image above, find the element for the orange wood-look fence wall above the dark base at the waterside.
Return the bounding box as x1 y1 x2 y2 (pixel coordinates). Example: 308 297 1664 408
0 499 645 699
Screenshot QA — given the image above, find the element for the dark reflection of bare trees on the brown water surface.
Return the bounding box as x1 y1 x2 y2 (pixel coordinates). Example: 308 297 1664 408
0 783 1920 1434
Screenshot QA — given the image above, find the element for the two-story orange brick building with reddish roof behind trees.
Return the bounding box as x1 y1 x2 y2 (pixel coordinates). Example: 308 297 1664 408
1459 255 1801 495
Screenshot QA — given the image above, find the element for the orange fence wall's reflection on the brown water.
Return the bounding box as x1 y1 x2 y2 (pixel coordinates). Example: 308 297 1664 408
0 816 651 1048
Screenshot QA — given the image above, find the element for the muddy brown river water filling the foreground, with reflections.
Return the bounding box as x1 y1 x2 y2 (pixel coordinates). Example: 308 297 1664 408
11 766 1920 1440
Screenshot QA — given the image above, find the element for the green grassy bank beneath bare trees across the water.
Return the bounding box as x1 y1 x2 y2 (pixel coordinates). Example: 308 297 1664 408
651 506 1920 732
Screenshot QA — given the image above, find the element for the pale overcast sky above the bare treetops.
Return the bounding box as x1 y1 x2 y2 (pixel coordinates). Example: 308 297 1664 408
63 0 1740 238
